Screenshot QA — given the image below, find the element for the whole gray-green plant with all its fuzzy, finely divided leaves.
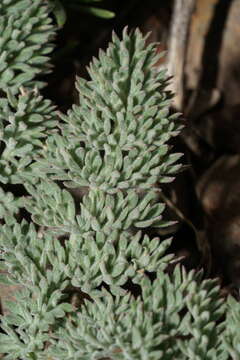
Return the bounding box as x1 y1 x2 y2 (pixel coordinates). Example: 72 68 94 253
0 0 240 360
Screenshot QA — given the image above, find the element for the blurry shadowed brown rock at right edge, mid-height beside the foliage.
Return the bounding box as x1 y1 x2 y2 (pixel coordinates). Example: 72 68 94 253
197 155 240 285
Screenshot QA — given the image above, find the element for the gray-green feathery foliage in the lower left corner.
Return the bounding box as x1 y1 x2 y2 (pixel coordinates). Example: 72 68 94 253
0 222 72 359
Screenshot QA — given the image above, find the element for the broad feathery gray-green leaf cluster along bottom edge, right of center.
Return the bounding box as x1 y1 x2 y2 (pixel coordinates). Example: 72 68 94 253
50 267 225 360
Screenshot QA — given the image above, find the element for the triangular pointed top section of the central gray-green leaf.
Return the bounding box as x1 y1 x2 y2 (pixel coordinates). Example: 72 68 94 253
36 31 181 194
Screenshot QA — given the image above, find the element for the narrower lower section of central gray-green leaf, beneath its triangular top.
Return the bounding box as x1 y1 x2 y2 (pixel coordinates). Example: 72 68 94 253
25 181 174 294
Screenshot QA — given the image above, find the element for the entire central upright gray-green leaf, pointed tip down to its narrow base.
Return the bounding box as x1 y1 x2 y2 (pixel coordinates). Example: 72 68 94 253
26 31 183 295
